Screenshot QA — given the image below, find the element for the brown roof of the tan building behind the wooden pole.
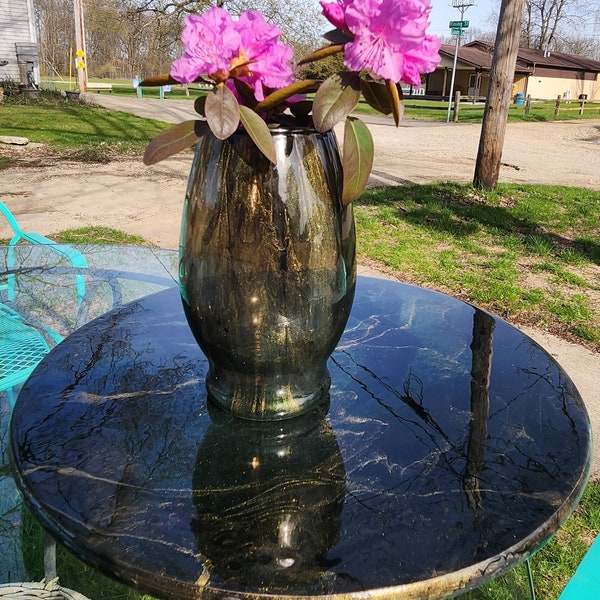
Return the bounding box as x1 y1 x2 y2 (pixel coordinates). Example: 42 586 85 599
440 40 600 73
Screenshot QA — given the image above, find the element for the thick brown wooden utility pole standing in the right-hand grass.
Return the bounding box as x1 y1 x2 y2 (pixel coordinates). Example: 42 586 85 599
473 0 525 191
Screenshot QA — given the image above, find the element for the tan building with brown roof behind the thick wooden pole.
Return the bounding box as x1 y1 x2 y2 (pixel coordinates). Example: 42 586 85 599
426 41 600 102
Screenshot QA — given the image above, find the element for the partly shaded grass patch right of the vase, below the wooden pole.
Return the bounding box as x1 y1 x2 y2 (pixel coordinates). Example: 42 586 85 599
355 183 600 350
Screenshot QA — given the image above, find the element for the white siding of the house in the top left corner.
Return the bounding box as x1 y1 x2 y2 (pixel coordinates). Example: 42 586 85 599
0 0 40 83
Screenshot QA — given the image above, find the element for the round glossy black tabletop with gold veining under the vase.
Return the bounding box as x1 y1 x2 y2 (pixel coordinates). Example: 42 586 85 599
11 278 591 599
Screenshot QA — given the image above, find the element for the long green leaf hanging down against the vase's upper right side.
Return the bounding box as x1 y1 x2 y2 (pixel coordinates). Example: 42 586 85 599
342 118 375 206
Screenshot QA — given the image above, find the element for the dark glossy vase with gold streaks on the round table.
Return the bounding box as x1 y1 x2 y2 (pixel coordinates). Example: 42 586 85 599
180 129 356 420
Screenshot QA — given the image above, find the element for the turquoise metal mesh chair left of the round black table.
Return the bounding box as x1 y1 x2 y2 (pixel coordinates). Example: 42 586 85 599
0 202 87 406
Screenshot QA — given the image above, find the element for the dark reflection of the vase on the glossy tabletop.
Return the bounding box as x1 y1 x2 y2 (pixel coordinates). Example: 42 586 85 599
191 402 346 589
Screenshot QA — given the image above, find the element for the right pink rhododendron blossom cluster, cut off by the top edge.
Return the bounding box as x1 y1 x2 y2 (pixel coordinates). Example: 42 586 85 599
322 0 440 85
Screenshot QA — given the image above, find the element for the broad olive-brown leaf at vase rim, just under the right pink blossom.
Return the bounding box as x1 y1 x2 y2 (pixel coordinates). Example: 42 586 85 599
313 73 360 131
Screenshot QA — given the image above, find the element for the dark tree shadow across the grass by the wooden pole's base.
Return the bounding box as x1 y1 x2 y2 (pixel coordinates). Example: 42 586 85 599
358 183 600 264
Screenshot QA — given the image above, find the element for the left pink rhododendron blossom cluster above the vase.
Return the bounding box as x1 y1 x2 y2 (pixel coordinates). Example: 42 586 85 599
171 7 294 101
